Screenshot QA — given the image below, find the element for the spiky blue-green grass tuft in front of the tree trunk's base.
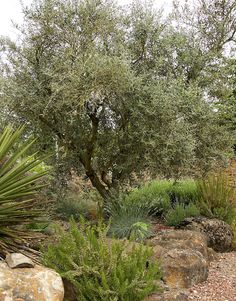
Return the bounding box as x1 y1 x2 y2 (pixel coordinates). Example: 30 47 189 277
106 198 152 241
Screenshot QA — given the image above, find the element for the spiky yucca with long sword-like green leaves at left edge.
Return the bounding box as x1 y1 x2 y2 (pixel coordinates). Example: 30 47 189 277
0 126 47 254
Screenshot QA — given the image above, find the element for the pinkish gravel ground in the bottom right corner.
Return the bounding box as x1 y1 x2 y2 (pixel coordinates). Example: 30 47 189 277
188 252 236 301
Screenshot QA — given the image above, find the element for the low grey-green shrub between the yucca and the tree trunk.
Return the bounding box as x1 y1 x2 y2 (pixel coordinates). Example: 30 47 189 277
55 196 97 221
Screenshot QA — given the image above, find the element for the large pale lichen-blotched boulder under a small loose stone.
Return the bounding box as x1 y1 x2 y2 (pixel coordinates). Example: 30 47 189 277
0 261 64 301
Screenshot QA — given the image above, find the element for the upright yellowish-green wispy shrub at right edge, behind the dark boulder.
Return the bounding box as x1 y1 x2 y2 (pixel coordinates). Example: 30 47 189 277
197 174 236 224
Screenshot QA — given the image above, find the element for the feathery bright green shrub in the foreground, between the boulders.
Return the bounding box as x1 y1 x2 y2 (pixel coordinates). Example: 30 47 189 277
43 221 160 301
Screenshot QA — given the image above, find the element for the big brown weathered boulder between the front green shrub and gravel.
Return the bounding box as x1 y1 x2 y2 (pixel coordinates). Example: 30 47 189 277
148 230 209 289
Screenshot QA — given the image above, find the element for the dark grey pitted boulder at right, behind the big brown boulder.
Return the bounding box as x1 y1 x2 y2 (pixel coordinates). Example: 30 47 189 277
180 217 234 252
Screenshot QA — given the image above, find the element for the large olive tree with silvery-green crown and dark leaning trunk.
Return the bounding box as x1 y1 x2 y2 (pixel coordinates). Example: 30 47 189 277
0 0 236 197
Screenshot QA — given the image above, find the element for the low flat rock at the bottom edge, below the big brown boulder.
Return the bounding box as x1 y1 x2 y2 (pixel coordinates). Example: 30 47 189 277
144 290 188 301
